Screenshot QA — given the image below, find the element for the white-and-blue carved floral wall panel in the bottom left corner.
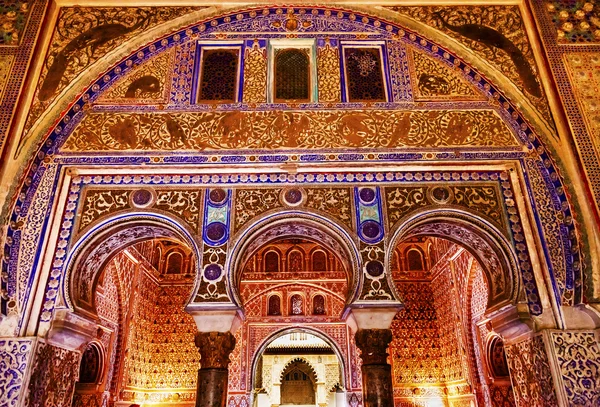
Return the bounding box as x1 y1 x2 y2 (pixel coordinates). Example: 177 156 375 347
0 338 34 407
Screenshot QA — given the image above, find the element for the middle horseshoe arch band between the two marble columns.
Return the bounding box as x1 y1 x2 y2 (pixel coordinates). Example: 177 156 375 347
225 211 362 307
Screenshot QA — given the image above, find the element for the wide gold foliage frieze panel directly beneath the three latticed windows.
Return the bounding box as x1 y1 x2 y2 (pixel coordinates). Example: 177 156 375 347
63 110 519 152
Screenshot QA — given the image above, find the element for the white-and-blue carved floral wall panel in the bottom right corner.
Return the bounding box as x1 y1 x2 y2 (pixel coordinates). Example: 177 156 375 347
551 331 600 407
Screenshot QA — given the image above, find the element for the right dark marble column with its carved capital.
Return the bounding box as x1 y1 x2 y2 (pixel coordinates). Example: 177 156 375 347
356 329 394 407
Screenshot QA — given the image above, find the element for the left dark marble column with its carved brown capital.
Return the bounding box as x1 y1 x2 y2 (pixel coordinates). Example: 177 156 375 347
196 332 235 407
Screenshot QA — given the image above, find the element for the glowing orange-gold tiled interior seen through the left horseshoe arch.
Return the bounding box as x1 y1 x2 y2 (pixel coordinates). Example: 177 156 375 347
73 238 200 407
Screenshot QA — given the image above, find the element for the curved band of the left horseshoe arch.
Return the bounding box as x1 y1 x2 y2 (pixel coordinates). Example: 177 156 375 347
63 213 200 320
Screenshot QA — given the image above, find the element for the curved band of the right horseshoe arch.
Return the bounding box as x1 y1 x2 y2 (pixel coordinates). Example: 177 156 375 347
386 209 521 312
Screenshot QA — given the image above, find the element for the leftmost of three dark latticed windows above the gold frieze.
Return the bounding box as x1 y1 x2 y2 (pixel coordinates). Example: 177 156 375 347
198 49 239 102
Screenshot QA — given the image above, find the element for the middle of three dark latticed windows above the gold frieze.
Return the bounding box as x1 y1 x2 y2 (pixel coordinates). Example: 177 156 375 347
275 48 310 102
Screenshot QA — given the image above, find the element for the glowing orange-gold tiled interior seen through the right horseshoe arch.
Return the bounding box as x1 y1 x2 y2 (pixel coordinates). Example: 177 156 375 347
389 235 515 407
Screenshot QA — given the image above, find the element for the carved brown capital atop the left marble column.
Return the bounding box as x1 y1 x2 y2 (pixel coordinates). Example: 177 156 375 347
195 332 235 369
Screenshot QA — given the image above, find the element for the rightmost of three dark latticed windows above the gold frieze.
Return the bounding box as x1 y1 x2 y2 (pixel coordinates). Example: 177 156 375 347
344 48 386 102
